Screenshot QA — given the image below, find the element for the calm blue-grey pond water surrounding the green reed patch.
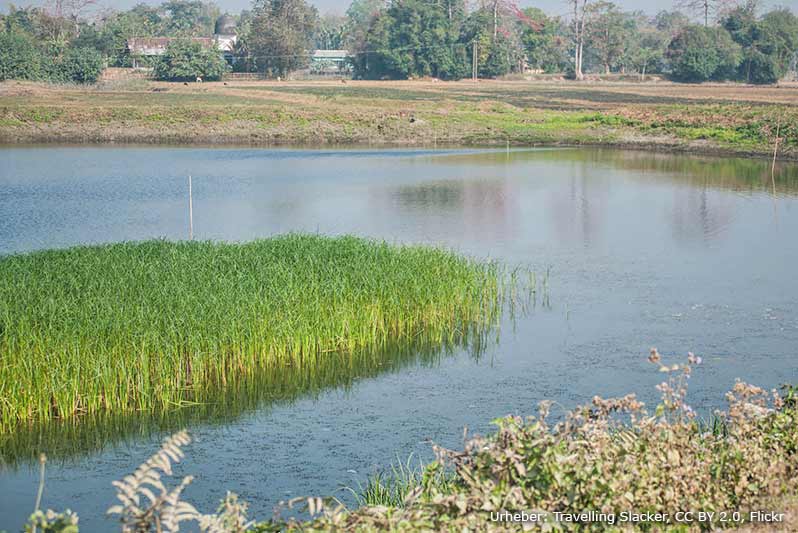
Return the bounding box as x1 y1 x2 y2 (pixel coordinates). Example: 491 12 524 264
0 147 798 532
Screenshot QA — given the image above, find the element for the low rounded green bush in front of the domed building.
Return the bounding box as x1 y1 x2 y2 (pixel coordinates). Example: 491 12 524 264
154 39 228 81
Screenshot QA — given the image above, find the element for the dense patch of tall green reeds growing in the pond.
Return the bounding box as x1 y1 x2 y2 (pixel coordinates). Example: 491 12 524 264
0 235 500 432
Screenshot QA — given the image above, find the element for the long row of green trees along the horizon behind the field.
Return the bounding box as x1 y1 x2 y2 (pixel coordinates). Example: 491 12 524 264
0 0 798 83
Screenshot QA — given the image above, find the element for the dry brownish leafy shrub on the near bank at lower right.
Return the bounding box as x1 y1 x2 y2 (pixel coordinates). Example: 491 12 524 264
284 349 798 531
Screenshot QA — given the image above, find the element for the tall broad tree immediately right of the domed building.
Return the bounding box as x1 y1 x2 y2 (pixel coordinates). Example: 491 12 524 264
247 0 319 76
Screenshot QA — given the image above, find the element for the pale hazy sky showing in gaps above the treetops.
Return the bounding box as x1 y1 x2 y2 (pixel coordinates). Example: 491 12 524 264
0 0 798 15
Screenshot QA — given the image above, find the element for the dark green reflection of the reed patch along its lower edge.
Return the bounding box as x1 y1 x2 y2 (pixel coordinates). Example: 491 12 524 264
0 331 495 469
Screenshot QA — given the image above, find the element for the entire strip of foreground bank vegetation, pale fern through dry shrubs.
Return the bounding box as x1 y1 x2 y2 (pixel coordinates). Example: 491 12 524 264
25 349 798 532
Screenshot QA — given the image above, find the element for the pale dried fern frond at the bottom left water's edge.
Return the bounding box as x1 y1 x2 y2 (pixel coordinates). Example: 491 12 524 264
108 431 201 533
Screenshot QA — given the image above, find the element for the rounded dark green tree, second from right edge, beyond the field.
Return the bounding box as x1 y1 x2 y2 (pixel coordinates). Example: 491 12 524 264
666 26 741 83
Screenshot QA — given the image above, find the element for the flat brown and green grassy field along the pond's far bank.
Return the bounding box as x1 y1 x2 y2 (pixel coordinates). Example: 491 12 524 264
0 81 798 159
